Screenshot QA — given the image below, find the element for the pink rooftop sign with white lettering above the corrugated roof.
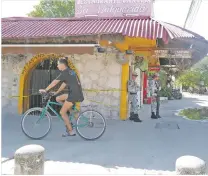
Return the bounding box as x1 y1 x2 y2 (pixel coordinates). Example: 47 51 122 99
75 0 153 17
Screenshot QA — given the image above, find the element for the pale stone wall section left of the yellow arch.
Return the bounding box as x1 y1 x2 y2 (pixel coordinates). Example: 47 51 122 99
1 54 32 114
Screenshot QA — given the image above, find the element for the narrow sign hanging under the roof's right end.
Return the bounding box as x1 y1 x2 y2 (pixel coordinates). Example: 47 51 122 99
155 50 192 59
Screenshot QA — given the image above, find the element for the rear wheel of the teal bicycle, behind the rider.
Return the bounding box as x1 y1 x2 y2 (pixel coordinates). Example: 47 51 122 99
76 110 106 140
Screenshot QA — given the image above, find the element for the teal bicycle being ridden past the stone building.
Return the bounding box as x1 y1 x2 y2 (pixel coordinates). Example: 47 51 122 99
21 93 106 140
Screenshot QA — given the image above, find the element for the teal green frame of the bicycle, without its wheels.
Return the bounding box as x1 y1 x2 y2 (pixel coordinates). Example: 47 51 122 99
38 100 88 127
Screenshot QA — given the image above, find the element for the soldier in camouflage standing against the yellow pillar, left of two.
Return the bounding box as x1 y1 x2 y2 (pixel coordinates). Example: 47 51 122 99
128 72 142 122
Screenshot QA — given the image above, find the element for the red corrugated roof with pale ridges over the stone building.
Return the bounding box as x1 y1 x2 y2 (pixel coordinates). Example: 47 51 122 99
2 17 203 42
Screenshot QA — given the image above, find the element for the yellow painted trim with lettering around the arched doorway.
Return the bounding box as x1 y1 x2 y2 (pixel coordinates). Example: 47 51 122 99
18 53 80 114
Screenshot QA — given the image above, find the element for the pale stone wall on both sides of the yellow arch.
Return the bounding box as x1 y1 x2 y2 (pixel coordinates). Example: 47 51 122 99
2 49 121 119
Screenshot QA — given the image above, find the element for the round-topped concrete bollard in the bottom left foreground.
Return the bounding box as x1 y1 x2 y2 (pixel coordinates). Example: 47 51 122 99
14 145 45 175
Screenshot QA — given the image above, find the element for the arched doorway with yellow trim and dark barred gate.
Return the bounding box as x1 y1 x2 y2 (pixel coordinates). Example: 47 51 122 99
18 54 79 114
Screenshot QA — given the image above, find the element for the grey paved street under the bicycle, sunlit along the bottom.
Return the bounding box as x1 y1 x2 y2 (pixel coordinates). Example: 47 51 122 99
2 94 208 174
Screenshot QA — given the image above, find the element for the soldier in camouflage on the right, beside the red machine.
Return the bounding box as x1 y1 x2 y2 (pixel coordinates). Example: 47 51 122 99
151 74 161 119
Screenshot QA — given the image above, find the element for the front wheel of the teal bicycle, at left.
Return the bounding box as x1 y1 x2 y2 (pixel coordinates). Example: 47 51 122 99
21 108 51 140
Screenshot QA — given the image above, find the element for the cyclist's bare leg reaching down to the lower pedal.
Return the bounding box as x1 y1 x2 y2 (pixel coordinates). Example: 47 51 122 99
60 101 73 134
